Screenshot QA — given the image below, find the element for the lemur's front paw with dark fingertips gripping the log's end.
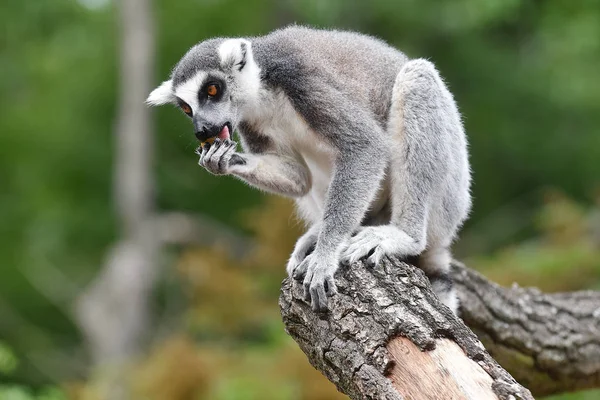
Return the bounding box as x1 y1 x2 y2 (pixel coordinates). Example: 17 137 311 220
294 253 338 312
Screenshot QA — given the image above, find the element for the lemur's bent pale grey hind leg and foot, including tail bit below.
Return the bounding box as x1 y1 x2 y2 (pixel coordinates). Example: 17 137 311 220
342 59 470 311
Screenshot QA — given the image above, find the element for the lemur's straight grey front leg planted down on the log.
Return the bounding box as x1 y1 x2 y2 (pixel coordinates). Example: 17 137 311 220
294 105 389 311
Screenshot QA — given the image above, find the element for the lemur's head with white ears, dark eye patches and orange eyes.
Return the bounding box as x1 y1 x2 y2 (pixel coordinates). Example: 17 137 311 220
146 39 260 142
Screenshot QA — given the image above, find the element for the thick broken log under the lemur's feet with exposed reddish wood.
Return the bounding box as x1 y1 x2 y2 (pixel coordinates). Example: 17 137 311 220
279 260 533 400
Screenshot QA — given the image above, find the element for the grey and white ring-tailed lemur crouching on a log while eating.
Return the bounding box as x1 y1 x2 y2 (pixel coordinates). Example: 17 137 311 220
147 26 471 311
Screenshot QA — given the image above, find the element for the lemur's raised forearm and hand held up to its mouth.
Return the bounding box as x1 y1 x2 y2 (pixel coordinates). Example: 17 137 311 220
199 139 311 197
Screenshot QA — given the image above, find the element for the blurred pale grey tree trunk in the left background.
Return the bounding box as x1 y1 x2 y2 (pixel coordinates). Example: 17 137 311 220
76 0 160 399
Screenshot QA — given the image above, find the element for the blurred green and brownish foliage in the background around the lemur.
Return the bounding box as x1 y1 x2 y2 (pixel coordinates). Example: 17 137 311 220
0 0 600 400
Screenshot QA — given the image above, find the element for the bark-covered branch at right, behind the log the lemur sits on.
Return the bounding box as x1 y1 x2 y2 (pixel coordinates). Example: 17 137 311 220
452 263 600 396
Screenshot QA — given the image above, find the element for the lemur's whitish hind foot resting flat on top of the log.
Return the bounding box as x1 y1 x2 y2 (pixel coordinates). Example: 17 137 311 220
341 225 424 266
